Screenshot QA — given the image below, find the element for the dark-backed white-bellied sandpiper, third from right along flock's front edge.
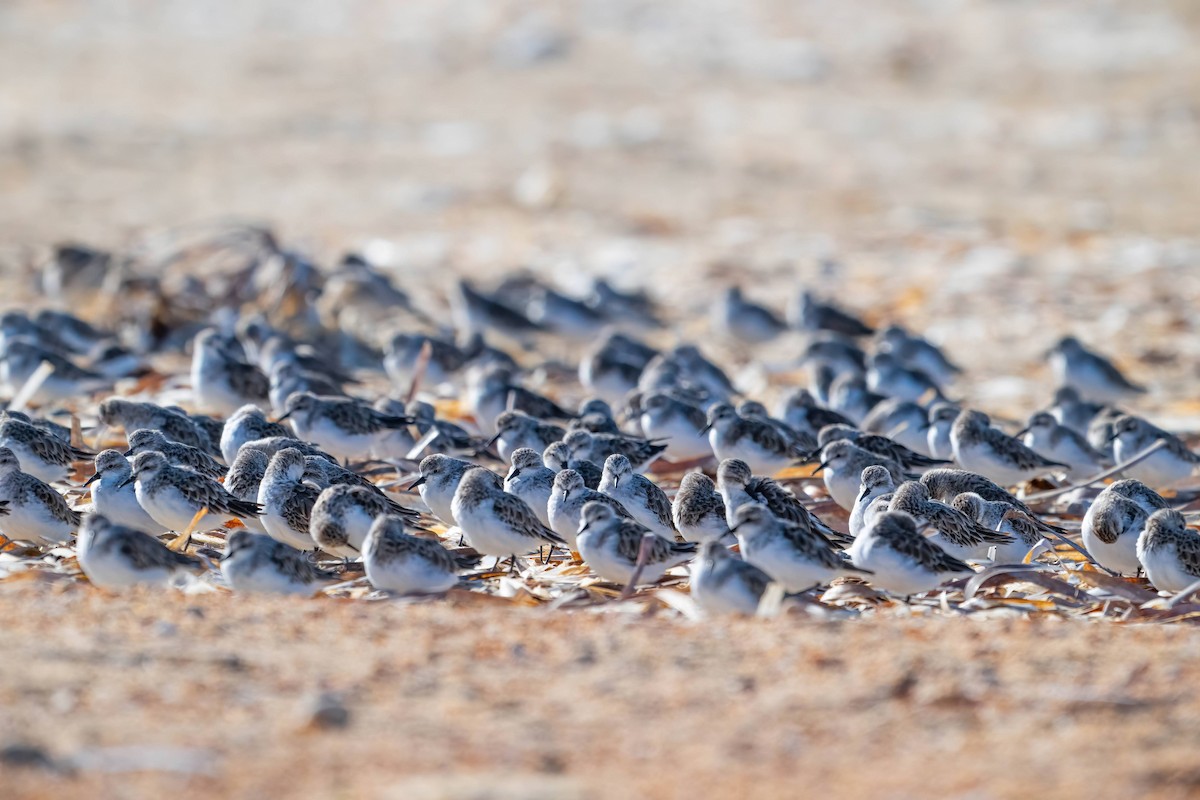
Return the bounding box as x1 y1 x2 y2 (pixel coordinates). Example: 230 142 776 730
847 511 974 597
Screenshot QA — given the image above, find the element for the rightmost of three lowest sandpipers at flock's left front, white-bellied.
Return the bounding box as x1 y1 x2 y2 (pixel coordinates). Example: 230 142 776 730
362 515 479 595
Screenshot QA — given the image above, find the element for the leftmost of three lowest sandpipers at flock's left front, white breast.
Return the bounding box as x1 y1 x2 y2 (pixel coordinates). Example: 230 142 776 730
77 513 204 590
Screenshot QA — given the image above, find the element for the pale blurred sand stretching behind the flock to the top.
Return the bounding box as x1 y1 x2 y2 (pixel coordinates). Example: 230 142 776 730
0 0 1200 400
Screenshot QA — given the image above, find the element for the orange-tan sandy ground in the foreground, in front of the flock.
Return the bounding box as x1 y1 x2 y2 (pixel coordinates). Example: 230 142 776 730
7 582 1200 799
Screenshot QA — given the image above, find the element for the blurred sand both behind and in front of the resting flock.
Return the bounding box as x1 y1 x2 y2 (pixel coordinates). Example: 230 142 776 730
0 0 1200 798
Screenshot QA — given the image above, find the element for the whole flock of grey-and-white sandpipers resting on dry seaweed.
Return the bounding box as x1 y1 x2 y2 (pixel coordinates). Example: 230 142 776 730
0 248 1200 614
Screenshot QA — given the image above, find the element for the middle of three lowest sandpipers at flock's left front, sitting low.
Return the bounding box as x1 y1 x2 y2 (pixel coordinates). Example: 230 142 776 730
221 530 337 596
